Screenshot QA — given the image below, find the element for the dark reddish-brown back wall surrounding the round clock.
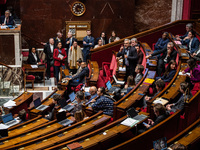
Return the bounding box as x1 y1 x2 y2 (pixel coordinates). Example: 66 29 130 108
20 0 135 47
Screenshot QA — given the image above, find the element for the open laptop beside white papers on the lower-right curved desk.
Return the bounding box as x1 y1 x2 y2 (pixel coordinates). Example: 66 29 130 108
126 107 148 122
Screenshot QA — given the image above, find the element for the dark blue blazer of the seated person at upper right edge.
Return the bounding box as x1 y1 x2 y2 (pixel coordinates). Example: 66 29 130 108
181 37 199 53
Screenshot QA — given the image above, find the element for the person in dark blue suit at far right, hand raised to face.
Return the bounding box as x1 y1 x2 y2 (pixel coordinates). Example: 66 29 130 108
181 31 199 54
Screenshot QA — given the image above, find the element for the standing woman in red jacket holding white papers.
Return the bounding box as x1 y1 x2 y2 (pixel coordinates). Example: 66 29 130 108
53 42 67 83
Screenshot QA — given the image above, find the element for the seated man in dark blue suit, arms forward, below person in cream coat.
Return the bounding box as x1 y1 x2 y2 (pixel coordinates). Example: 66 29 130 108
66 62 89 90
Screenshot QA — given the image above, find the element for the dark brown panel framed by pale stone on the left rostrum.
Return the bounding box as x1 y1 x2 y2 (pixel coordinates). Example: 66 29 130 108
0 35 15 65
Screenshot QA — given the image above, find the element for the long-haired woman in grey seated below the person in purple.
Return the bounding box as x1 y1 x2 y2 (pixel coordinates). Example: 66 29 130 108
166 82 192 113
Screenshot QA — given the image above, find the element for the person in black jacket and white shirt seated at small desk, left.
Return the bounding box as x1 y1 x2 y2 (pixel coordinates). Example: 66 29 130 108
27 47 41 65
